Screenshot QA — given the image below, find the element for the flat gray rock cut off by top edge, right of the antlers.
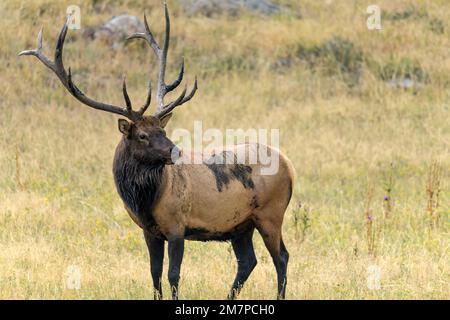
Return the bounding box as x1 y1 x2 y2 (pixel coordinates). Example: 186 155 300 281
179 0 289 17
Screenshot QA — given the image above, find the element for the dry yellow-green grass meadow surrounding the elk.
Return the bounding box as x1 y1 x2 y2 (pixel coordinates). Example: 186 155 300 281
0 0 450 299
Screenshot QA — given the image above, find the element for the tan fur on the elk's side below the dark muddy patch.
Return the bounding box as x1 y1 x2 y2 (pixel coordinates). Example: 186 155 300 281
153 146 293 242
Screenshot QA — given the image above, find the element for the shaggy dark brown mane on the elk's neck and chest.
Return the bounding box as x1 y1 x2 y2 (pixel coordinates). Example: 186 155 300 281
113 140 164 230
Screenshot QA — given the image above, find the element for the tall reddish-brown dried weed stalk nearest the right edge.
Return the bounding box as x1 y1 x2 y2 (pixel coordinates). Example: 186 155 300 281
426 160 442 227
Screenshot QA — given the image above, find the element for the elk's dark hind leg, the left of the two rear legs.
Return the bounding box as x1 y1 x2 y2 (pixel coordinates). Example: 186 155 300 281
228 227 257 300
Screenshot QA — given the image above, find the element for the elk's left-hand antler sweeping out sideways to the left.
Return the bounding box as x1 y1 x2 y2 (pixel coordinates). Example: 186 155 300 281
19 17 151 121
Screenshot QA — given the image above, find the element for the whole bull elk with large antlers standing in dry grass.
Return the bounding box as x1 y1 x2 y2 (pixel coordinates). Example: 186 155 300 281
20 6 294 299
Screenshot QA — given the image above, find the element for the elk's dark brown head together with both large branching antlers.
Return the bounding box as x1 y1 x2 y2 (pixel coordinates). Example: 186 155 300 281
19 4 197 164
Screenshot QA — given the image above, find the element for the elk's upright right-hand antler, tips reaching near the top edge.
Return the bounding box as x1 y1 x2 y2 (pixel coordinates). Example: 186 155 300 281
128 3 197 119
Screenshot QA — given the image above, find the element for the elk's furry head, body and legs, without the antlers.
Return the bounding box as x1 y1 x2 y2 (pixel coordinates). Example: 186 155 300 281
114 117 294 298
